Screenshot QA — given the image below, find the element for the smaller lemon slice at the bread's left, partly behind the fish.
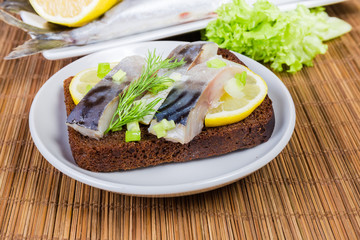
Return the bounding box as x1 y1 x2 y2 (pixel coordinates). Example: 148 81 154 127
69 63 117 104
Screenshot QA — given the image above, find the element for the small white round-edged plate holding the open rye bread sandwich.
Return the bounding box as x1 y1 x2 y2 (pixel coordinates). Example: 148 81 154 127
29 41 295 196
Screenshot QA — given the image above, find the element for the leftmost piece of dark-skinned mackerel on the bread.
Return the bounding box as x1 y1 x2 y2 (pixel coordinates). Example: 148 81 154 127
66 56 145 139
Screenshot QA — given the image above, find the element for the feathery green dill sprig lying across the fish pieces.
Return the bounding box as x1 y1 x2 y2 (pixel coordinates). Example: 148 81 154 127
105 50 185 133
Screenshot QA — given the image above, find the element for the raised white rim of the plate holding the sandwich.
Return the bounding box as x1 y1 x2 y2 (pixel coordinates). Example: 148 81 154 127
29 41 296 197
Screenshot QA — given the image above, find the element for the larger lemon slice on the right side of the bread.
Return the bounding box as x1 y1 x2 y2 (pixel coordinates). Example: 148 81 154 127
205 67 268 127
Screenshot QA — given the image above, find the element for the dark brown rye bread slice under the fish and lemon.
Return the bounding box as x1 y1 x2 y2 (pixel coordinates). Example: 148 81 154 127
64 49 275 172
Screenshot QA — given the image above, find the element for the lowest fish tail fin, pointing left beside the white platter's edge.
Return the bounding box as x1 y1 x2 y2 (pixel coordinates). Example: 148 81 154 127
4 38 69 60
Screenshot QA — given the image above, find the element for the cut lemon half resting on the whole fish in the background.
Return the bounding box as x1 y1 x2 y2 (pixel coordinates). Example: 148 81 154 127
30 0 119 27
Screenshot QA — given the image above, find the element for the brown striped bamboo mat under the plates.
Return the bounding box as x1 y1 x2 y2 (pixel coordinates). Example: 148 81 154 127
0 0 360 239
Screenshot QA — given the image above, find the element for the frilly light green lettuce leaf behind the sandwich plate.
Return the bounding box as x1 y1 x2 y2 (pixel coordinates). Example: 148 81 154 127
205 0 351 73
